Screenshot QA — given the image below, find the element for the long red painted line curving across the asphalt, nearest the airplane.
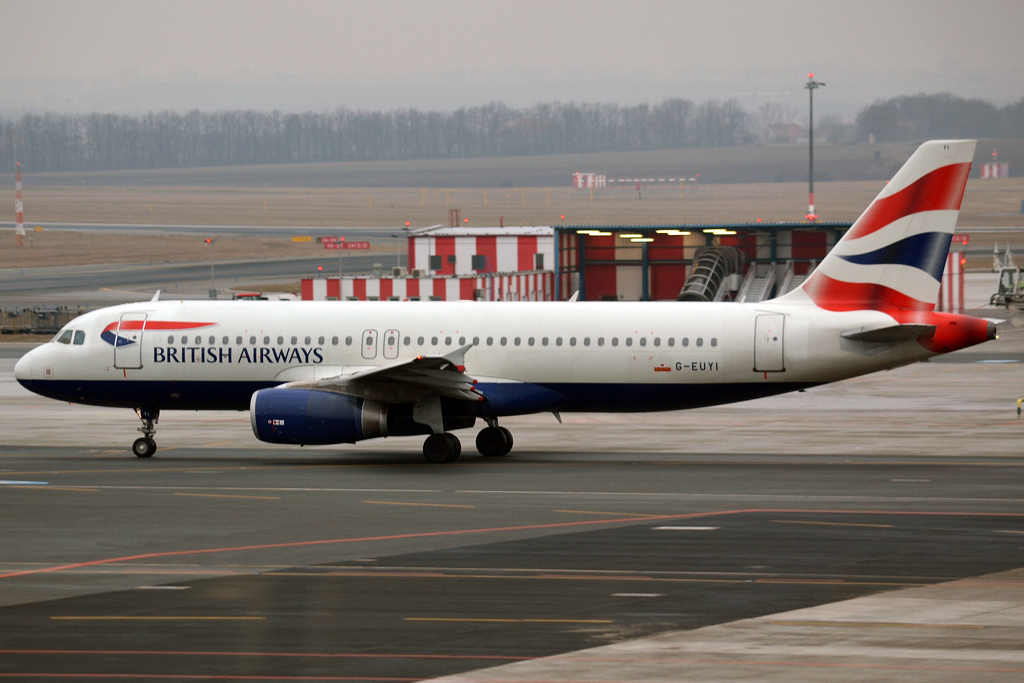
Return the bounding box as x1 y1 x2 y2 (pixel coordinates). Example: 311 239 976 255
0 508 1024 579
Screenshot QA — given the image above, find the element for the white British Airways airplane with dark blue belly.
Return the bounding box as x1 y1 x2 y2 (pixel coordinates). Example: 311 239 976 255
14 140 995 463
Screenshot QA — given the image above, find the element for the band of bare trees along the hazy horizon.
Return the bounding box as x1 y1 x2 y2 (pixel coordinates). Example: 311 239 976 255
0 94 1024 171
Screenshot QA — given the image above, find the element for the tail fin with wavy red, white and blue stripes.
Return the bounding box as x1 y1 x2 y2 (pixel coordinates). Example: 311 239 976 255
791 140 977 310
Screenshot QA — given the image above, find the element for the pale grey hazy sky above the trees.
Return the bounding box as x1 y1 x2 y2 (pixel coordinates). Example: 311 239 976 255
0 0 1024 115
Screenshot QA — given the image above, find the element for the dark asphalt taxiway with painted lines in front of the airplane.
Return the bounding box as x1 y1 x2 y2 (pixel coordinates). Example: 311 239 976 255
0 446 1024 681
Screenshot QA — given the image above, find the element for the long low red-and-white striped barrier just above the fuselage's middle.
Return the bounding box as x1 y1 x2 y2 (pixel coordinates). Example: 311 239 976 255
302 270 555 301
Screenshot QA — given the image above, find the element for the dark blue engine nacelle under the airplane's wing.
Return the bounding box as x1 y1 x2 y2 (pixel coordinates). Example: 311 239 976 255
249 387 388 445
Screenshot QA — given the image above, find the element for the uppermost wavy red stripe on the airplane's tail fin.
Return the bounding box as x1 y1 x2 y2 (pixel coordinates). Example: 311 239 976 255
846 162 971 240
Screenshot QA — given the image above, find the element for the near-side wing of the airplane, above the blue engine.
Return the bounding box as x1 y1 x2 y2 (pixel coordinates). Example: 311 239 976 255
284 344 483 402
